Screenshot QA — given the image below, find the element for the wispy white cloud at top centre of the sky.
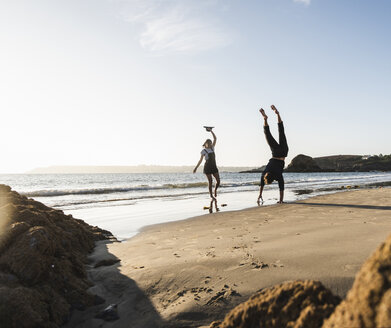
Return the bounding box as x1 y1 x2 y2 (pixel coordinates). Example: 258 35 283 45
113 0 232 54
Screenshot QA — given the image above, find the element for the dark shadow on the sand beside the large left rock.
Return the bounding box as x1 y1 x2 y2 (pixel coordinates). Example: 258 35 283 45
63 241 168 328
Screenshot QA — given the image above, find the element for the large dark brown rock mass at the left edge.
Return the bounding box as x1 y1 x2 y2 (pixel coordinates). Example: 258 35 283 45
0 185 112 328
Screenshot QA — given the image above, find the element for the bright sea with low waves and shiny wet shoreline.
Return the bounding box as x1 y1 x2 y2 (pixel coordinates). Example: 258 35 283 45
0 172 391 240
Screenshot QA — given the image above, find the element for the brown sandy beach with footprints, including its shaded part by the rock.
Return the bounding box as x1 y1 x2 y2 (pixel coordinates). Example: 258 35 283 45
67 189 391 327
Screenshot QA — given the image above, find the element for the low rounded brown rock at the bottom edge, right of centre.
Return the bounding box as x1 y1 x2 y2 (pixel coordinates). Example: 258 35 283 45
210 281 341 328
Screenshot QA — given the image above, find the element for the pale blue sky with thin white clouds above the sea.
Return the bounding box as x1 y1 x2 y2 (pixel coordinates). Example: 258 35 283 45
0 0 391 173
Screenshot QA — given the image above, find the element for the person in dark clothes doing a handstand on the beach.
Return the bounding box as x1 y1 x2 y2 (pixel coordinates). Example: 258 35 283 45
258 105 289 204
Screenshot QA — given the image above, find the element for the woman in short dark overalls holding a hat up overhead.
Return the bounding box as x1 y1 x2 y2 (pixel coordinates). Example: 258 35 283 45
193 128 220 200
